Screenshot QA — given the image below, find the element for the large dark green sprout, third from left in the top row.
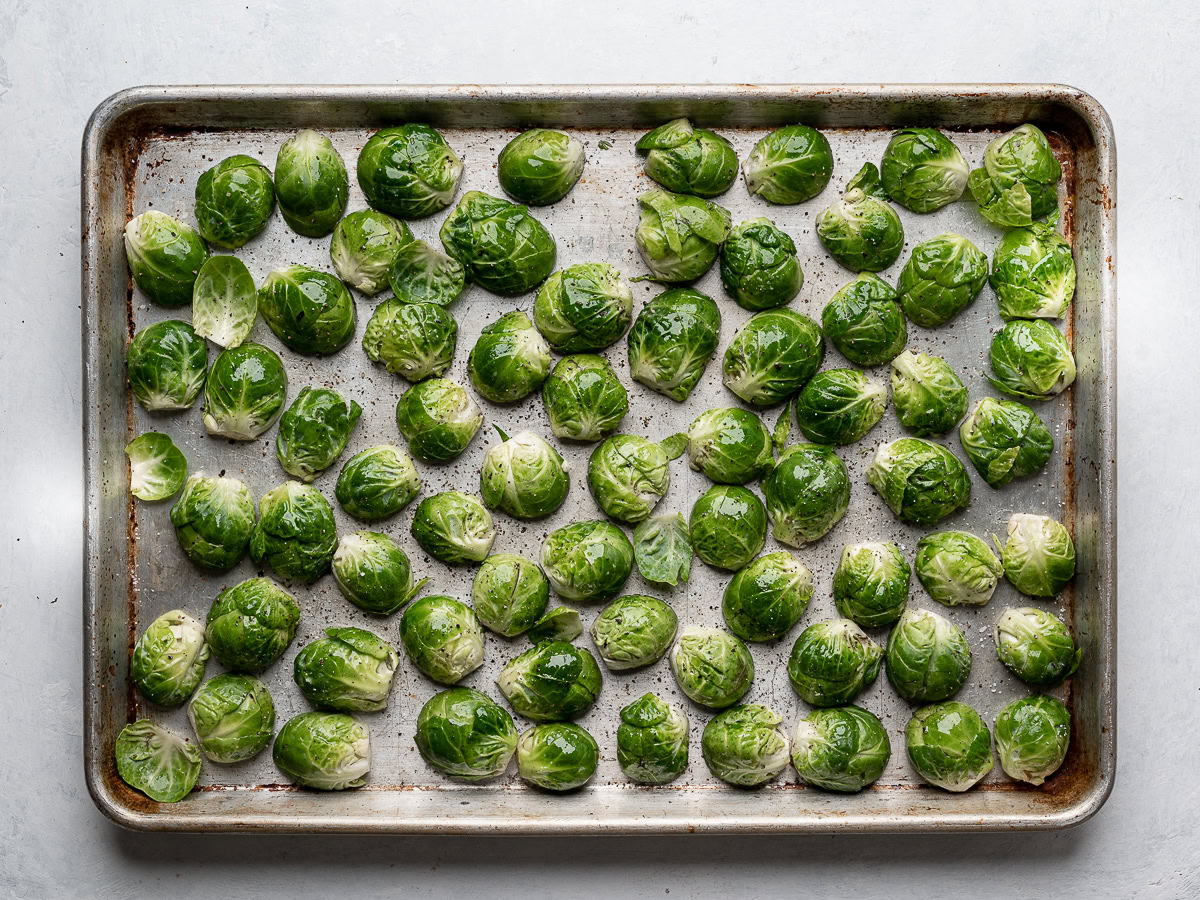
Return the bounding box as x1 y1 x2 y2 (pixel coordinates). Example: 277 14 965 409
358 122 462 218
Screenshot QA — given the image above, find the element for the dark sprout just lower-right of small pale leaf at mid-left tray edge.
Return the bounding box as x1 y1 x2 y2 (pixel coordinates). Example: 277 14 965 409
170 473 254 570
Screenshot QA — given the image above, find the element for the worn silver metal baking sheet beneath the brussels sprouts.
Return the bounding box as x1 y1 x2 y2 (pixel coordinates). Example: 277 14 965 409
83 85 1116 834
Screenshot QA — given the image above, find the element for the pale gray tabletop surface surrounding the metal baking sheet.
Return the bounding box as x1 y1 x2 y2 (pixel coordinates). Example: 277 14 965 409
0 0 1200 900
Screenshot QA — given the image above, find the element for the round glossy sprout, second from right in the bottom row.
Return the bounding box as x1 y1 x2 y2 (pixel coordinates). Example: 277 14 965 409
905 700 995 792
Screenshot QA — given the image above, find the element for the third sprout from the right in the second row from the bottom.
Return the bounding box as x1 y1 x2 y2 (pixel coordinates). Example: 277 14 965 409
787 619 883 707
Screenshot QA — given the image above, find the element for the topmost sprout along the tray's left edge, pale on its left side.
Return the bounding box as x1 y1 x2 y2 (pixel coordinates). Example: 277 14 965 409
125 210 209 306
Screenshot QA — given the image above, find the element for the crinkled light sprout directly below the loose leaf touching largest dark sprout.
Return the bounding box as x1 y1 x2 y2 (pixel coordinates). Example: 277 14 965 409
362 298 458 382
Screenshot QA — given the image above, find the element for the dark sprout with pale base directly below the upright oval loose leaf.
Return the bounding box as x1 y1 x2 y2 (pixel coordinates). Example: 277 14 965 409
204 343 288 440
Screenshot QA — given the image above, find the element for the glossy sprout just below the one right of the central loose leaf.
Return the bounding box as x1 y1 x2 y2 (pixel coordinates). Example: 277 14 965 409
721 551 812 642
